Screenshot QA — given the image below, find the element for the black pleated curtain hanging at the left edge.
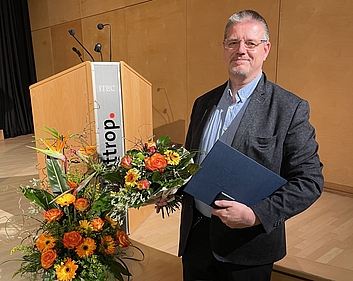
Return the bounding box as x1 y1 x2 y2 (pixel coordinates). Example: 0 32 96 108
0 0 36 138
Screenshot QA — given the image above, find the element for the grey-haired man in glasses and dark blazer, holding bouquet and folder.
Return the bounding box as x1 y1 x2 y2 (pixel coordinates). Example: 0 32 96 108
176 10 323 281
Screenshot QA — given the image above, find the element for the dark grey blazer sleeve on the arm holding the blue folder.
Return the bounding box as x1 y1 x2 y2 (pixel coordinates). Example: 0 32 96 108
251 100 324 233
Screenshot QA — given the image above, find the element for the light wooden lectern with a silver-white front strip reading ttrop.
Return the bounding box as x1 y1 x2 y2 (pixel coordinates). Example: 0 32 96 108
30 62 153 233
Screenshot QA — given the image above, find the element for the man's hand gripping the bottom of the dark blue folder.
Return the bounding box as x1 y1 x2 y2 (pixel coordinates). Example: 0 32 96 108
212 200 260 228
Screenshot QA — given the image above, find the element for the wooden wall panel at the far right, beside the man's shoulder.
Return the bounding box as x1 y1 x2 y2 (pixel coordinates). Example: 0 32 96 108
278 0 353 190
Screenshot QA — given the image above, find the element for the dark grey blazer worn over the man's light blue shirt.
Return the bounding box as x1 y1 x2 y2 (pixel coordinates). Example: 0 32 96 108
179 73 324 265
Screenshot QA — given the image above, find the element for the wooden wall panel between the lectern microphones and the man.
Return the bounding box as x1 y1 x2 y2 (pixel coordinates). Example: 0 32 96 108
126 0 187 143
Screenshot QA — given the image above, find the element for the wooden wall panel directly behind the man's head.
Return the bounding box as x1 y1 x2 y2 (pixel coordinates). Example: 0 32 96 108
186 0 279 127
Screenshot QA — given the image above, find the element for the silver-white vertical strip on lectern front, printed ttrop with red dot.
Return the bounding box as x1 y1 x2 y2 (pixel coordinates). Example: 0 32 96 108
91 62 124 165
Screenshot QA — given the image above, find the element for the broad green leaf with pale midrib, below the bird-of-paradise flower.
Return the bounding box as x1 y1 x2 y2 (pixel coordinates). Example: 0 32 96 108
46 157 69 196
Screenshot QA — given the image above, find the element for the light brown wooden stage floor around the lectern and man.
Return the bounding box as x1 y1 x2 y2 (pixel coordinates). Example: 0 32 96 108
0 135 353 281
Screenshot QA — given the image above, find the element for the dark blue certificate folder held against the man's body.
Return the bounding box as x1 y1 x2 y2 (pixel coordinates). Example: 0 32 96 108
184 140 287 206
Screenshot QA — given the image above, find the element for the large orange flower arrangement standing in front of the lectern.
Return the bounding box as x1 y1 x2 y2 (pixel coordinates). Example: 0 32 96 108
5 128 143 281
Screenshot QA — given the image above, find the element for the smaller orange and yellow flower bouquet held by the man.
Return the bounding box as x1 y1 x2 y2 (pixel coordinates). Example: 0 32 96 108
105 136 200 218
